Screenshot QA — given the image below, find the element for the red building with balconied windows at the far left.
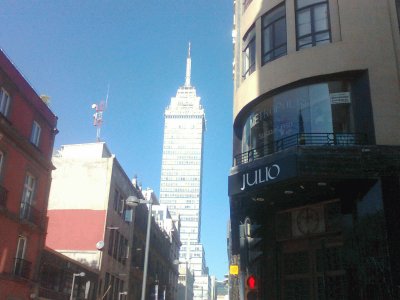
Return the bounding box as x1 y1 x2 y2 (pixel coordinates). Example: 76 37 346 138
0 50 57 300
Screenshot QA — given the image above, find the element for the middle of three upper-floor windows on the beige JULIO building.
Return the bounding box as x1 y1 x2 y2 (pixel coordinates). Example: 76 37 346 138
261 5 286 64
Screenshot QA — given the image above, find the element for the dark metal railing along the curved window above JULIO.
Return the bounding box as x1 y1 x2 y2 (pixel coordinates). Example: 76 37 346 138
233 133 367 166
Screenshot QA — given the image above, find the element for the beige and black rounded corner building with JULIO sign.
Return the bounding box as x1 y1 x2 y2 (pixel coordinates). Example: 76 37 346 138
229 0 400 300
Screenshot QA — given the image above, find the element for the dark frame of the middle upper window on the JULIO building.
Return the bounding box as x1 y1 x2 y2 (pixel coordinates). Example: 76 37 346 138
261 2 287 65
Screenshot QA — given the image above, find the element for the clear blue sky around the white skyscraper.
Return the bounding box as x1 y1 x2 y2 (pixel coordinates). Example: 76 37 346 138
0 0 233 279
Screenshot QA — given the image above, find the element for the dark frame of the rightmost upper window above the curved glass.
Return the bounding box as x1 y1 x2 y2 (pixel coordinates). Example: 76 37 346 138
295 0 332 51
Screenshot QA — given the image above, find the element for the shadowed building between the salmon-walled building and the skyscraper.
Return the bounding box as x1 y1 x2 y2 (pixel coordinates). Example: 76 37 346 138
129 190 180 300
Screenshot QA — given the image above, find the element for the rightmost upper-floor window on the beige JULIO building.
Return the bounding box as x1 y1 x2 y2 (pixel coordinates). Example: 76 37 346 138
296 0 331 50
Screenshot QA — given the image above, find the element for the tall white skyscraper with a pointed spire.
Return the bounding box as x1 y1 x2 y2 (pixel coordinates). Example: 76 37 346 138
160 44 208 298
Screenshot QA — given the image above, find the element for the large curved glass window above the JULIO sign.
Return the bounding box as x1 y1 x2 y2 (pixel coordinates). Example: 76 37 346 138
242 81 354 155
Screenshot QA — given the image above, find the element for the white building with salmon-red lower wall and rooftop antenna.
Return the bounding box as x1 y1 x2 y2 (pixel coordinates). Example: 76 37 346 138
46 142 143 299
